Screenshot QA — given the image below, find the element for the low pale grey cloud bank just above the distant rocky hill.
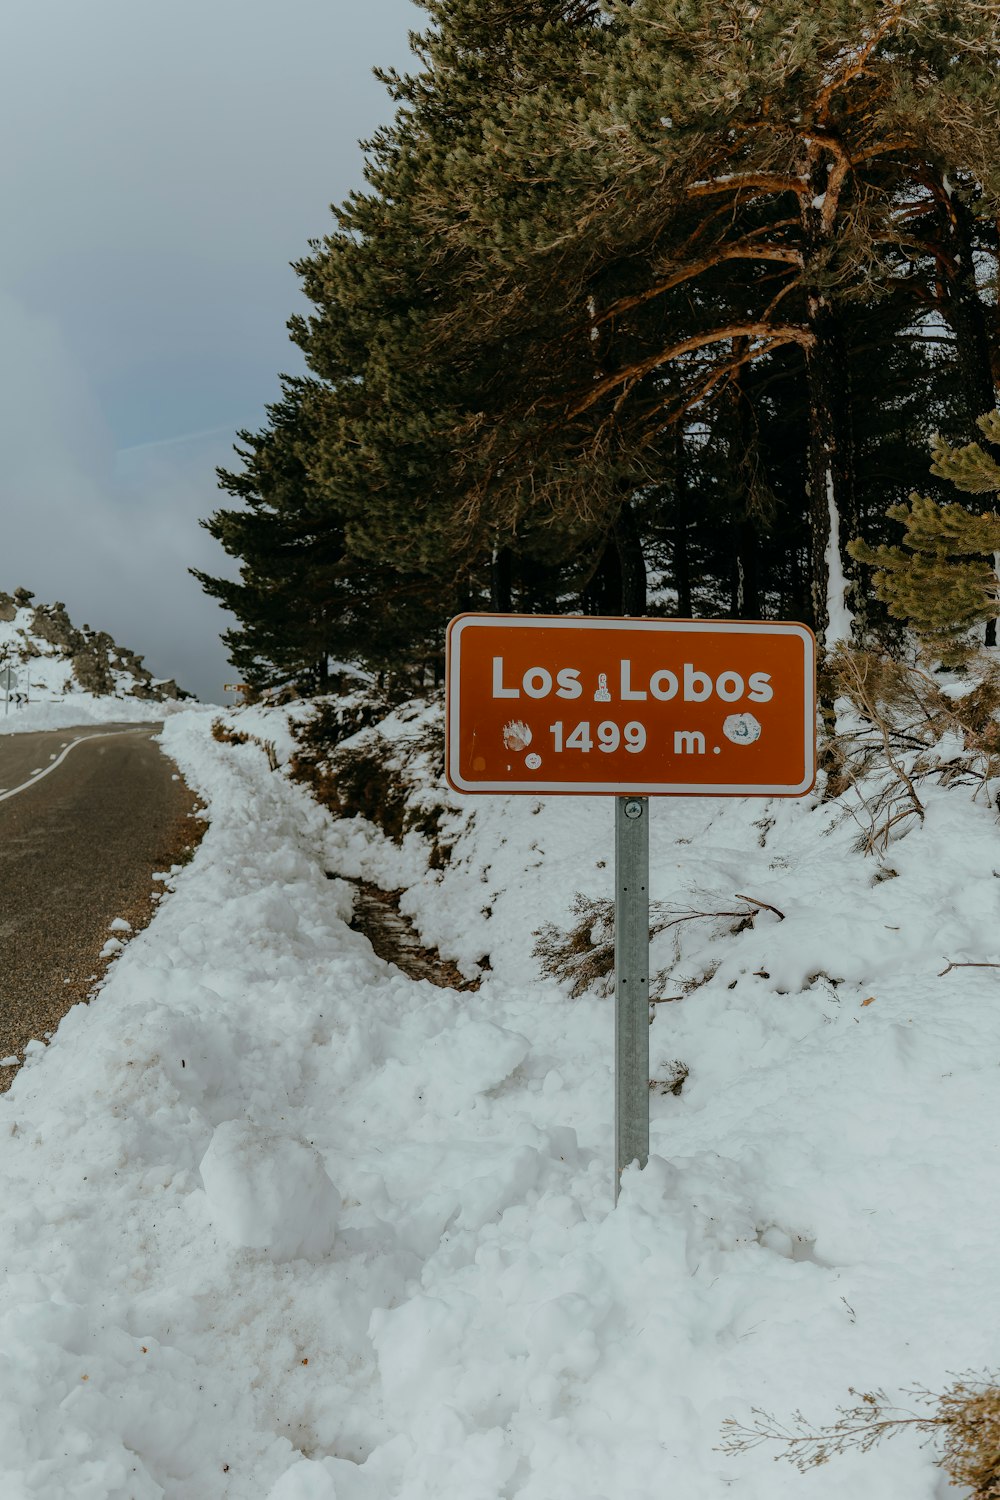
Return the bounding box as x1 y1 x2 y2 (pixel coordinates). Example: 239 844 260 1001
0 296 231 701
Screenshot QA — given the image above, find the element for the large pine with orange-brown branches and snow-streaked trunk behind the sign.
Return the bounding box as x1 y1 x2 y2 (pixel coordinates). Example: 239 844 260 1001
407 0 997 639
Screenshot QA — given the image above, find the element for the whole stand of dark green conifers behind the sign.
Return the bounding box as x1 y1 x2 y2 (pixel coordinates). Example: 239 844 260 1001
198 0 1000 692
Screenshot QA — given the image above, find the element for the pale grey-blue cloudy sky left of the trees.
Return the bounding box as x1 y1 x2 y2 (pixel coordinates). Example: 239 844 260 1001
0 0 424 702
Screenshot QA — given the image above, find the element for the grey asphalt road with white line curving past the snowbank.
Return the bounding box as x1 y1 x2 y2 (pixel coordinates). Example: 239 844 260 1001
0 725 201 1091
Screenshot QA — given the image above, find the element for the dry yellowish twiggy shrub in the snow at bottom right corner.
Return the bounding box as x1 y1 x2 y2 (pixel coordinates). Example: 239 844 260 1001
720 1373 1000 1500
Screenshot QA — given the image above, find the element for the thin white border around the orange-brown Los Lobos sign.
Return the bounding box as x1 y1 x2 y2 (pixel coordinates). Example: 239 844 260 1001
445 614 816 797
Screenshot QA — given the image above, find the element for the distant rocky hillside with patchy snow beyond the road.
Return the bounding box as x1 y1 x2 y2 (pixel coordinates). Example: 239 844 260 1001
0 588 193 734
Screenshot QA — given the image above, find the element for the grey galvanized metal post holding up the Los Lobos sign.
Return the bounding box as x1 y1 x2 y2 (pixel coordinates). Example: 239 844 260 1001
615 797 649 1202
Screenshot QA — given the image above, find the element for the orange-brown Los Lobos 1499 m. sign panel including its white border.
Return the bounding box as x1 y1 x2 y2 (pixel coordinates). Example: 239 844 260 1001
447 615 816 797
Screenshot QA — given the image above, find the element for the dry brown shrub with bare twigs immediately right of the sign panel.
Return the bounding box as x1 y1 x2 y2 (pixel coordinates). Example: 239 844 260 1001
820 647 1000 855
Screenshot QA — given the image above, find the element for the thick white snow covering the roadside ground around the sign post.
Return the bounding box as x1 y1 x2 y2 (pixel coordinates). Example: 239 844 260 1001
0 696 1000 1500
